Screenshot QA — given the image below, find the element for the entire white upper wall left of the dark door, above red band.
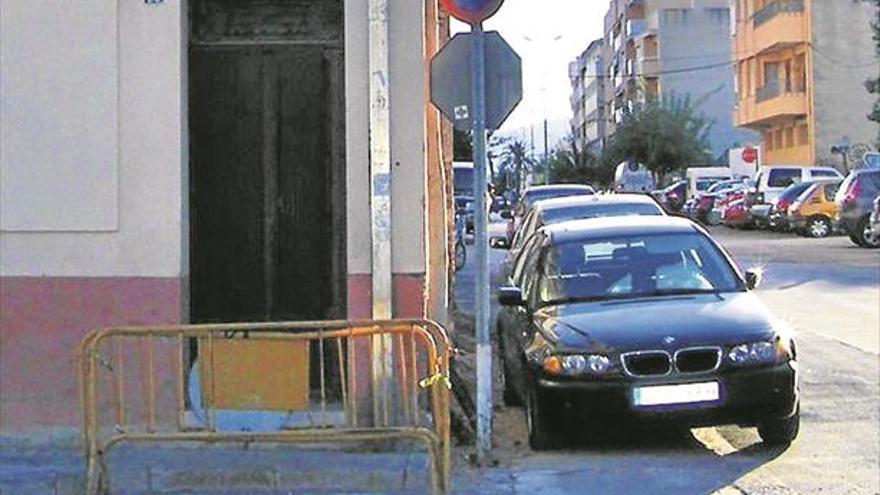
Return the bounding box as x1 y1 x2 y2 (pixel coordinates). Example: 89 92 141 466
0 0 188 277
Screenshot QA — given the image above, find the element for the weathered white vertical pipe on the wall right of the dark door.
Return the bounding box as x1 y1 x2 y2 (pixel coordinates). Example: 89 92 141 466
369 0 393 423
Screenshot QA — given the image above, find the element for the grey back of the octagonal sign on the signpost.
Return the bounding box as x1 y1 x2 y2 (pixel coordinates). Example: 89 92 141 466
431 31 522 130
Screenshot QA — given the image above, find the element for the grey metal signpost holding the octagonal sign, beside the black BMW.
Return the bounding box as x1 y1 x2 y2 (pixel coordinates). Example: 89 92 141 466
471 23 492 463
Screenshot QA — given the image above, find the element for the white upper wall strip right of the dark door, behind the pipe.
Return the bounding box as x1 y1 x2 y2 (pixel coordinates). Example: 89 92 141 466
345 0 425 274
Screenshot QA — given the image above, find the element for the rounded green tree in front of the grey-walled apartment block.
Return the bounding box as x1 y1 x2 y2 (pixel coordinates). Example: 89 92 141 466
604 96 711 184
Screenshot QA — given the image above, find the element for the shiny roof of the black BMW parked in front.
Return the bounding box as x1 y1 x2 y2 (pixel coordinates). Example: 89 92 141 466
541 216 700 245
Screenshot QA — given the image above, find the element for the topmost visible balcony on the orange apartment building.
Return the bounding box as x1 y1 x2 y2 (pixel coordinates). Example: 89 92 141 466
737 0 809 56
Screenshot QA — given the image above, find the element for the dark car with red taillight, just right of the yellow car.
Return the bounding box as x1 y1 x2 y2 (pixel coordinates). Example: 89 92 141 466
834 169 880 248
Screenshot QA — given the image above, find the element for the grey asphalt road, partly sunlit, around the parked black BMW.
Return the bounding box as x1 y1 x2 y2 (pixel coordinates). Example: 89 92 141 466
456 224 880 495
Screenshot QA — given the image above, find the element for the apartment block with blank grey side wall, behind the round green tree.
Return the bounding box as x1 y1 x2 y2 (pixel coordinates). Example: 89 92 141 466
605 0 759 157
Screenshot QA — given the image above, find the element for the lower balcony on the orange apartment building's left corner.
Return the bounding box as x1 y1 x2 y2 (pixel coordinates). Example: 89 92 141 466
736 85 809 129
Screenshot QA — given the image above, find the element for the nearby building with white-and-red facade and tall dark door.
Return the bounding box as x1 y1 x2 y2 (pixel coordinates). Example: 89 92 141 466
0 0 451 434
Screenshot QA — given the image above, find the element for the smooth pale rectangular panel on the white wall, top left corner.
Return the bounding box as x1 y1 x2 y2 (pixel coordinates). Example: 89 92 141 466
0 0 118 231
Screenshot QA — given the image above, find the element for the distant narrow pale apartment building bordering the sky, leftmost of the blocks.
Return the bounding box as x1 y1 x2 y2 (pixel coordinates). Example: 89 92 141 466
568 38 606 153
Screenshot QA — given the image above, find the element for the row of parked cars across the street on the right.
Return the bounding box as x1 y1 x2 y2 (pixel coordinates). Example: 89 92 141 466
661 166 880 248
